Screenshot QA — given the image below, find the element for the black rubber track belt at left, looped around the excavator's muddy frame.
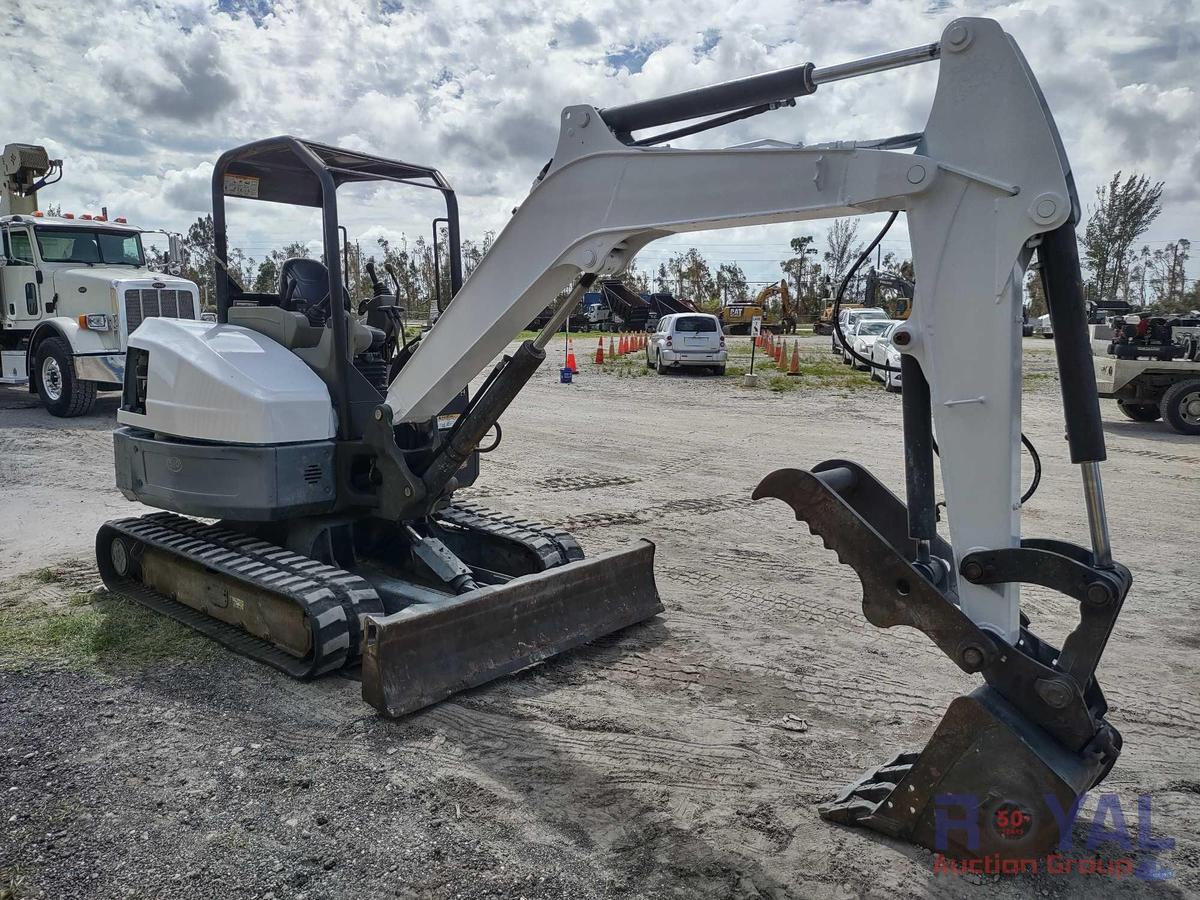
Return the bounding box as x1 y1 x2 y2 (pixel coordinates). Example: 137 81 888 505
97 512 383 678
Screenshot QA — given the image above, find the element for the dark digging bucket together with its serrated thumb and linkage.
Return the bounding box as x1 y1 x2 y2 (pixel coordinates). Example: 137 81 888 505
754 460 1129 859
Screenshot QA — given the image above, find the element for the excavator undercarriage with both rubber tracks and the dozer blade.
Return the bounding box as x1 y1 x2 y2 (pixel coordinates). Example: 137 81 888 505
96 504 662 715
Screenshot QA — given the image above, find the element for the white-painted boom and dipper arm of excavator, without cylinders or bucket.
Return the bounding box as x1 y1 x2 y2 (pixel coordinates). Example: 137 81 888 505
386 19 1075 641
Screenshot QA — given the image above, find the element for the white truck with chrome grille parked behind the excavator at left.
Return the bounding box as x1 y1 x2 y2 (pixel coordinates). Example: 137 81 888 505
0 144 200 416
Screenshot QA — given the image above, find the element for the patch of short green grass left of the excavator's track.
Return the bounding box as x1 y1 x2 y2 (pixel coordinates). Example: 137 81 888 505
0 593 212 667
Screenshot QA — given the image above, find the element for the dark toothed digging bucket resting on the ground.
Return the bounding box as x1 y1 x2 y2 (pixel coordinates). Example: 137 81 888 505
818 686 1108 859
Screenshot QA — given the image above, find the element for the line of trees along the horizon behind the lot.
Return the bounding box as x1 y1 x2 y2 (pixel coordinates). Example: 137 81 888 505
166 172 1200 319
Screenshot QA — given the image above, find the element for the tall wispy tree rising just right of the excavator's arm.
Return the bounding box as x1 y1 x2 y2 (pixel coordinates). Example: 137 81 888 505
1084 170 1163 300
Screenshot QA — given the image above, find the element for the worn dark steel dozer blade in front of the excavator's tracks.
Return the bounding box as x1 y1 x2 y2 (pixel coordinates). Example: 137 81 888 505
362 540 662 716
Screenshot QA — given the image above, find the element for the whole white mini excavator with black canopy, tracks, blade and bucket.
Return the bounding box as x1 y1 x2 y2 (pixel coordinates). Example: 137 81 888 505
96 18 1132 858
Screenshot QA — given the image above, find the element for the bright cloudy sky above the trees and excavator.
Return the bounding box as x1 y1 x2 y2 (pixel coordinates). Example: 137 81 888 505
0 0 1200 289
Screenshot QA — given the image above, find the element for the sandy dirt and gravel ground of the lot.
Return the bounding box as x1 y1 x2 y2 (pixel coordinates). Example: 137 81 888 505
0 338 1200 900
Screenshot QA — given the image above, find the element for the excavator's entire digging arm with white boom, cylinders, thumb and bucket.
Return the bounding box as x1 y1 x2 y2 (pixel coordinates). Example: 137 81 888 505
384 18 1130 856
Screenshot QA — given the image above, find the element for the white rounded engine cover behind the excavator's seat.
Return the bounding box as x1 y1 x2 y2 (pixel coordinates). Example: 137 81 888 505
116 317 337 444
